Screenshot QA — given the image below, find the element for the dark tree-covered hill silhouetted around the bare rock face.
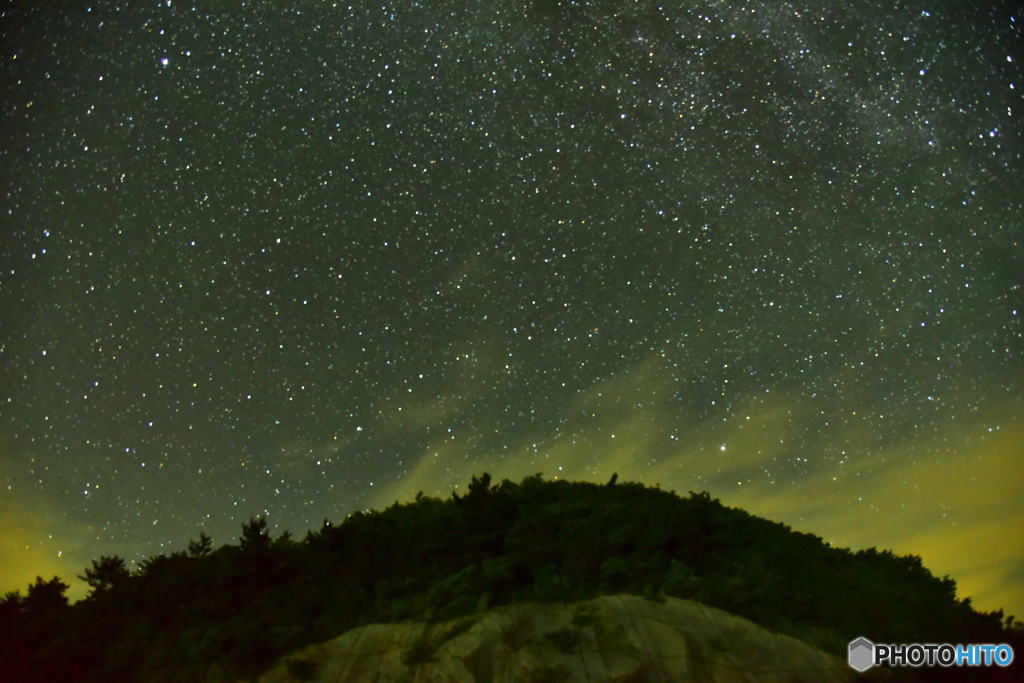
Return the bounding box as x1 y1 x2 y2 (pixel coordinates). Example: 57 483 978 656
0 474 1022 681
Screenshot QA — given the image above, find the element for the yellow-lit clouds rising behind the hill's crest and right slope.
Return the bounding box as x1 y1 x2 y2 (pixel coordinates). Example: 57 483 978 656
373 352 1024 616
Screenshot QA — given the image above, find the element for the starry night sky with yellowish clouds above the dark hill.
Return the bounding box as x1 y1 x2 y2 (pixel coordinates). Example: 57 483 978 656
0 0 1024 615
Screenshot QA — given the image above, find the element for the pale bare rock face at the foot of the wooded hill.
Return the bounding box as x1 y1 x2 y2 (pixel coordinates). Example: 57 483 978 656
259 595 856 683
